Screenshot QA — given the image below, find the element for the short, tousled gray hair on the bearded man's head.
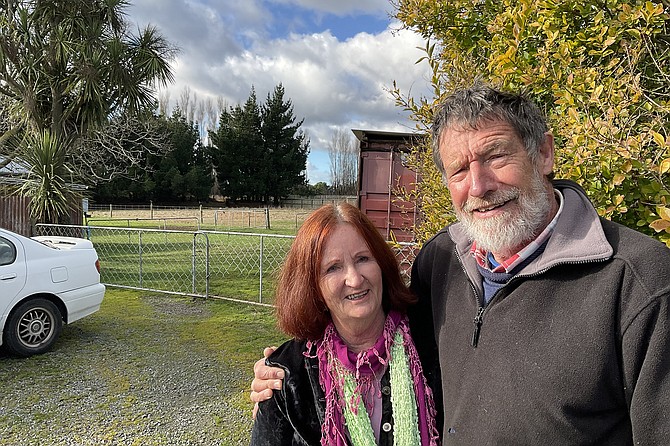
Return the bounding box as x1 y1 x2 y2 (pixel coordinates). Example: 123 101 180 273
431 83 549 175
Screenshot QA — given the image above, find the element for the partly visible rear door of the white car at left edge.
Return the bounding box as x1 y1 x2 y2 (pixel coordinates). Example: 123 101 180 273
0 233 26 321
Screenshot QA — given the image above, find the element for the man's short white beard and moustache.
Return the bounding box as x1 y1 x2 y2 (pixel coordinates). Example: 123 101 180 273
456 172 551 256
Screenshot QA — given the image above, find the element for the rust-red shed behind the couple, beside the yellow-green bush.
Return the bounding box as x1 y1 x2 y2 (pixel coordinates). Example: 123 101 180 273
352 130 422 242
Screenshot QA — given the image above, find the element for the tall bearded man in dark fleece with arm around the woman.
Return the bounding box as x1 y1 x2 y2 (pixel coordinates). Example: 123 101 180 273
252 85 670 445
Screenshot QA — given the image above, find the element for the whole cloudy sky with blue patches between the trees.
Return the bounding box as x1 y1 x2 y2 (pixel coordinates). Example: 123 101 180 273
127 0 429 184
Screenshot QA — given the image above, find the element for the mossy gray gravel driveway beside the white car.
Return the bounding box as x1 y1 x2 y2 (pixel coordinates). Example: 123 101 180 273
0 291 268 446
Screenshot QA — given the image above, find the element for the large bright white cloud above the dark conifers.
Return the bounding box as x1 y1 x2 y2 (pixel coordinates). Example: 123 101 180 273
217 25 427 125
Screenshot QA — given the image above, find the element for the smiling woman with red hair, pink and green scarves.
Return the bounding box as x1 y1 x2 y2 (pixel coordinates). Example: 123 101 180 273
251 203 439 446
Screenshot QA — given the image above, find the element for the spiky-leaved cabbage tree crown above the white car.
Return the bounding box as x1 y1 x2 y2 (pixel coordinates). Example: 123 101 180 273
0 0 175 219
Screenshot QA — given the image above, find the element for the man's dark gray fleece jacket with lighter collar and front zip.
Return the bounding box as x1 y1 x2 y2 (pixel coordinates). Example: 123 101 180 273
410 181 670 446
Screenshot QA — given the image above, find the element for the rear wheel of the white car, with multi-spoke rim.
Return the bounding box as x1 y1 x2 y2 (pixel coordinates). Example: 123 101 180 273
5 298 63 357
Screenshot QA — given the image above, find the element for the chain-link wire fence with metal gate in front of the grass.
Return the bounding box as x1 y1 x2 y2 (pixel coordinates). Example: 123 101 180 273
36 224 417 305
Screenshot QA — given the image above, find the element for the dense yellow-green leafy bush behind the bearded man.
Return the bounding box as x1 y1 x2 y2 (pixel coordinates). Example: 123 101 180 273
393 0 670 246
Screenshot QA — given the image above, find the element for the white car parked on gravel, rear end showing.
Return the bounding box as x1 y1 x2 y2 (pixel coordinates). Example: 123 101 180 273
0 228 105 357
